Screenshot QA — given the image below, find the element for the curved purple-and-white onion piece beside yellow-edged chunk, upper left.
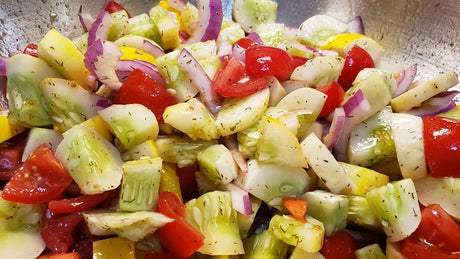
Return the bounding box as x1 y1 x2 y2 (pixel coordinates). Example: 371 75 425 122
84 40 123 90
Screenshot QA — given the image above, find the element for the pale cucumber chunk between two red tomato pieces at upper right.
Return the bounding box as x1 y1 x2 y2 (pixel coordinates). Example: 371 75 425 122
291 56 345 86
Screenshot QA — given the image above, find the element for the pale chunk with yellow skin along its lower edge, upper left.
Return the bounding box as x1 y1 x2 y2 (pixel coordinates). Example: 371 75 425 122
38 29 91 88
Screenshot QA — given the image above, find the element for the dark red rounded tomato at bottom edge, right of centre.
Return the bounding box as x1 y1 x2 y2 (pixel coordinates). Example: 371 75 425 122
321 230 356 259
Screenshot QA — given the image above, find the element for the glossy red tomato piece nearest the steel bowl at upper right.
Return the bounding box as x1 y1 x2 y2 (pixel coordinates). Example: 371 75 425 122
338 46 375 91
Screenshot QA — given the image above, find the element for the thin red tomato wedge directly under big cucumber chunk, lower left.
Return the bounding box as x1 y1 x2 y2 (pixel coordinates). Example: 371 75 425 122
48 190 114 213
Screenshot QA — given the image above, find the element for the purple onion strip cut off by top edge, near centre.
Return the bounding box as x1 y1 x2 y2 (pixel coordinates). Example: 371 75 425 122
187 0 224 43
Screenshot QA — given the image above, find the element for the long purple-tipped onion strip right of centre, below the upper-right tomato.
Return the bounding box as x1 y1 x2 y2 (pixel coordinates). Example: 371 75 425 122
334 90 371 162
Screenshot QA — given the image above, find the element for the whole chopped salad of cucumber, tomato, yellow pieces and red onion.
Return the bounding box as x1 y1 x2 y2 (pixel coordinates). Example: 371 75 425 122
0 0 460 259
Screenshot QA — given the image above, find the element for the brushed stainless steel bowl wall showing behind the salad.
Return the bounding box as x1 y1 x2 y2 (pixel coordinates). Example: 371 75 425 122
0 0 460 88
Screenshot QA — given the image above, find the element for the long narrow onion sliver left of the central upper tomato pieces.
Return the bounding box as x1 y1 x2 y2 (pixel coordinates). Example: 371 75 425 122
177 48 221 115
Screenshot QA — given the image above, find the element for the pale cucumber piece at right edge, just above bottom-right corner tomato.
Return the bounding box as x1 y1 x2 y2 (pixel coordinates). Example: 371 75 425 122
414 177 460 220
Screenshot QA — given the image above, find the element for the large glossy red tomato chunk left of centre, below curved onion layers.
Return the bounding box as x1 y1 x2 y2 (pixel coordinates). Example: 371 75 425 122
114 69 177 122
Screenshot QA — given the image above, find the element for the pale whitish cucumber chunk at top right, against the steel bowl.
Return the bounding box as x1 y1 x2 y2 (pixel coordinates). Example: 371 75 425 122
296 15 348 47
